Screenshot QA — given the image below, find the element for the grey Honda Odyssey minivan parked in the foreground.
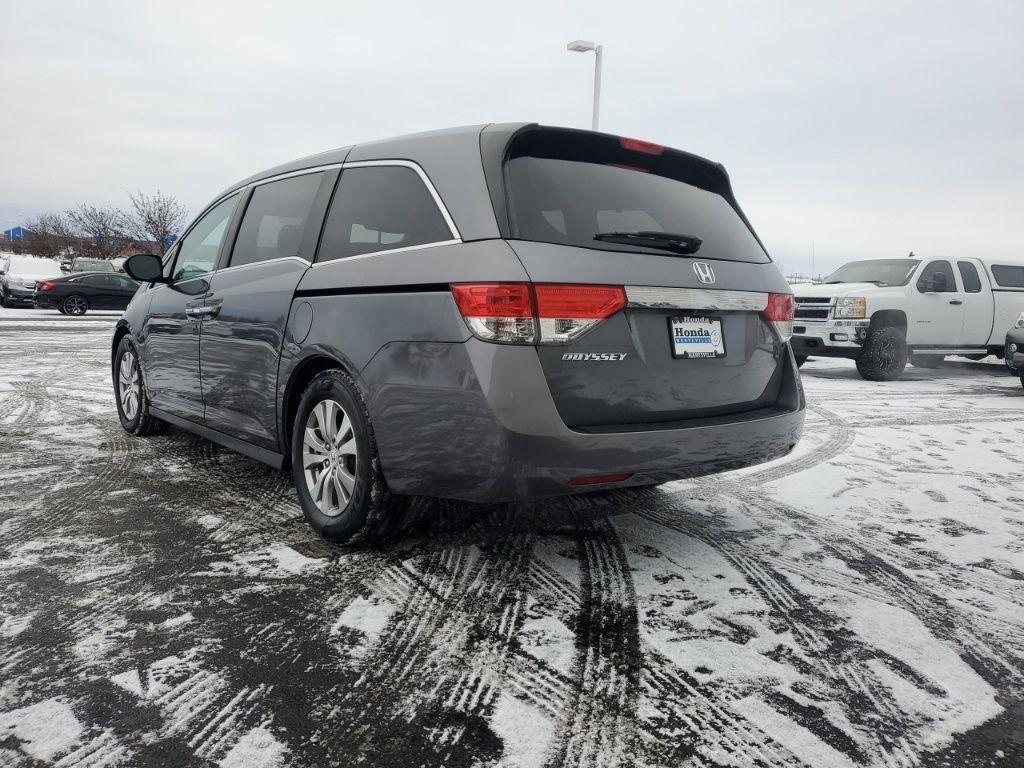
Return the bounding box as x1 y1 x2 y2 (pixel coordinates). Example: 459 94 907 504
112 124 805 540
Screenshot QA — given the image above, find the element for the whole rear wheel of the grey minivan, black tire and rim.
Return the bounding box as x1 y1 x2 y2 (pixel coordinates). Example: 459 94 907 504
291 371 409 544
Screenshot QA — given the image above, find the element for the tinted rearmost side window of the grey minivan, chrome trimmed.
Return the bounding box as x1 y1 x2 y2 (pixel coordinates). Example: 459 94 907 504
316 166 453 261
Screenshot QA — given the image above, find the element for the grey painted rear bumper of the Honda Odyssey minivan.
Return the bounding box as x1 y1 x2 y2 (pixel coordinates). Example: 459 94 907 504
360 339 805 502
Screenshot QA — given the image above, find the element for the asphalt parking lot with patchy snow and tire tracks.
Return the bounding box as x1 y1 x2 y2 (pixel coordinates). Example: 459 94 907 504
0 310 1024 768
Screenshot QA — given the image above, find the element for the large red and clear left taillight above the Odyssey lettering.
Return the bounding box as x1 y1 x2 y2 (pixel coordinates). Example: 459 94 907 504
452 283 626 344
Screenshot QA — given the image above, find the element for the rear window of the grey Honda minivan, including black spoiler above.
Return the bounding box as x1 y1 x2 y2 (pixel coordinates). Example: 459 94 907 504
506 130 769 263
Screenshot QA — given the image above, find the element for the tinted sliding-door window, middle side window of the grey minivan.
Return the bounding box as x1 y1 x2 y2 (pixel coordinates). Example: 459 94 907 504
231 173 324 266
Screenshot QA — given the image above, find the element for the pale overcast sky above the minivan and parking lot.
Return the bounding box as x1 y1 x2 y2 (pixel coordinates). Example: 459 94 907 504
0 0 1024 271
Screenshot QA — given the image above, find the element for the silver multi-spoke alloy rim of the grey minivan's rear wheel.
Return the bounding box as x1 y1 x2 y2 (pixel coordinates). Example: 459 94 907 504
302 399 357 517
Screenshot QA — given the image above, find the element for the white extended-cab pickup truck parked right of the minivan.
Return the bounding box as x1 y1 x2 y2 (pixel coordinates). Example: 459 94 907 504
793 258 1024 381
